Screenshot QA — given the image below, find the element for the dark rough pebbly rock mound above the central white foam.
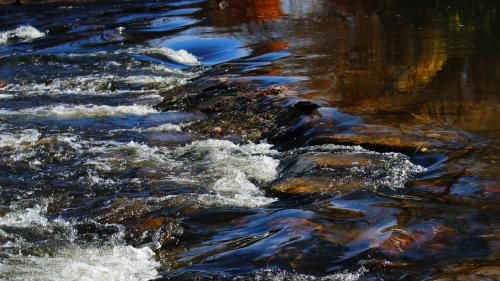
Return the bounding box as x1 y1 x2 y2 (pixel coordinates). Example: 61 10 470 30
156 79 290 142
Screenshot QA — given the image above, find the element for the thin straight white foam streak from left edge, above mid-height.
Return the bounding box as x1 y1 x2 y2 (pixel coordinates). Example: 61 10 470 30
0 104 159 118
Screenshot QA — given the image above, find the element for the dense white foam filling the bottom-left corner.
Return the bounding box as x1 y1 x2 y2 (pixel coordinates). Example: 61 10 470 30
0 246 159 281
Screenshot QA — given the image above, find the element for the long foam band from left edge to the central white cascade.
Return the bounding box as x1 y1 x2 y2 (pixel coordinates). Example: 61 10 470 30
0 135 279 207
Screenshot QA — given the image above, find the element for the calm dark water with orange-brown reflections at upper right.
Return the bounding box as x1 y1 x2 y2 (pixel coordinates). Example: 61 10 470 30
209 1 498 134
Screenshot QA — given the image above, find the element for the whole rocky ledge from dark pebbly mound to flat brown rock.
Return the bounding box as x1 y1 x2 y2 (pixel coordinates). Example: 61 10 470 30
157 75 469 156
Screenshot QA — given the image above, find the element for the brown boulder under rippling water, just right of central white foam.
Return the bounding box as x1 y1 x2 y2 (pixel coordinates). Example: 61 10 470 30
271 145 425 194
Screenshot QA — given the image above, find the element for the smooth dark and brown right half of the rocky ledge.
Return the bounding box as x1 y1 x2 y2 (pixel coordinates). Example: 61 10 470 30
270 101 469 155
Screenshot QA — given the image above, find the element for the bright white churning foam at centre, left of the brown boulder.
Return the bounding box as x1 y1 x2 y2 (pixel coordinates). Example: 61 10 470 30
180 140 279 207
